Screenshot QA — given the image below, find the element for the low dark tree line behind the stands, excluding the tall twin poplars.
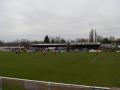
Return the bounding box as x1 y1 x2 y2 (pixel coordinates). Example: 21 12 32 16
0 34 120 48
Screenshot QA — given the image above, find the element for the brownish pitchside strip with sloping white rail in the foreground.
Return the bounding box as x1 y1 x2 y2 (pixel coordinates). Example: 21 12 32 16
0 77 117 90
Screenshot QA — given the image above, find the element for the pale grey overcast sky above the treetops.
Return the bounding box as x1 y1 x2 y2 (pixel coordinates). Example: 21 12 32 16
0 0 120 41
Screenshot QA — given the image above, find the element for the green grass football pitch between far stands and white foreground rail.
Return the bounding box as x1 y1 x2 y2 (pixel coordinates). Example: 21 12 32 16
0 52 120 87
